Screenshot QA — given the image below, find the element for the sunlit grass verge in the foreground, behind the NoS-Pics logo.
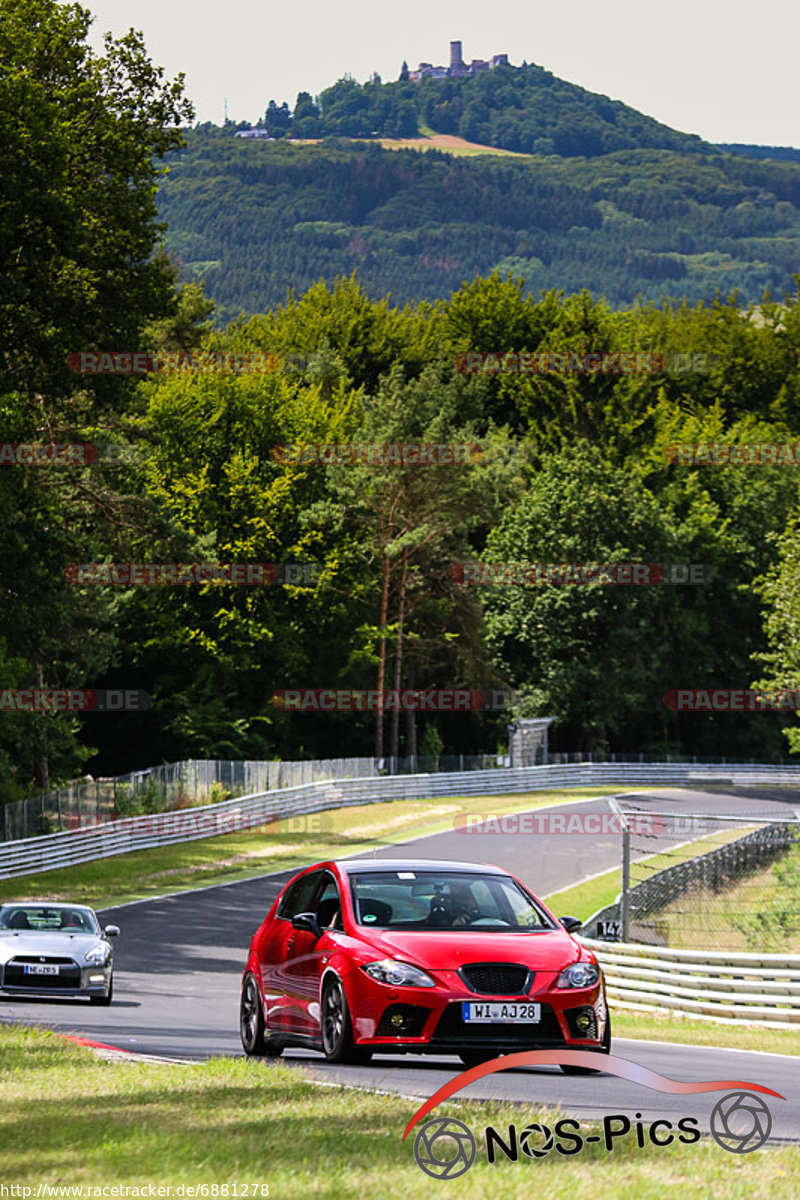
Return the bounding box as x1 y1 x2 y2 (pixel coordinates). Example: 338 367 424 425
0 1026 800 1200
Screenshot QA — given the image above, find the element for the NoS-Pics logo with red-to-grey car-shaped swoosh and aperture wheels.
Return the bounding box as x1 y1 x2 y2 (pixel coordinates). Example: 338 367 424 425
403 1050 786 1180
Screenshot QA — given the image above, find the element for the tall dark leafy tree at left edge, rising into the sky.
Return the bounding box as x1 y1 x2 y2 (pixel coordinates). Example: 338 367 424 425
0 0 192 792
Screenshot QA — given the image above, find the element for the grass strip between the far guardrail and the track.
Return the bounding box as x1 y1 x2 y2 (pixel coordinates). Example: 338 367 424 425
0 787 619 908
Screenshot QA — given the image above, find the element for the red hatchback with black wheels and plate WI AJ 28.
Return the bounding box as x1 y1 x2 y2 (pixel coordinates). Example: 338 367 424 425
240 858 610 1074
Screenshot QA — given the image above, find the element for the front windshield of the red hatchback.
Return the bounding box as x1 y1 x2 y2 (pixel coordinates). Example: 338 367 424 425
350 871 558 934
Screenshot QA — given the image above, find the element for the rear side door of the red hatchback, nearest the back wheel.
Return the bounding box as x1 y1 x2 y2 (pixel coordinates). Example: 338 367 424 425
259 871 323 1031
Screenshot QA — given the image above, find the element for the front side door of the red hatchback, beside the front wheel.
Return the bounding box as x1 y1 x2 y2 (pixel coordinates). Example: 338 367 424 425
285 871 342 1036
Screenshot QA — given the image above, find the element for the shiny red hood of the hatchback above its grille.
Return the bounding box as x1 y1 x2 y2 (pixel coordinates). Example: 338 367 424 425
352 929 582 971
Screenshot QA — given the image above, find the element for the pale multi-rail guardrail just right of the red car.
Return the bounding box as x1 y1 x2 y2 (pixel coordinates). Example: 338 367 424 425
581 936 800 1028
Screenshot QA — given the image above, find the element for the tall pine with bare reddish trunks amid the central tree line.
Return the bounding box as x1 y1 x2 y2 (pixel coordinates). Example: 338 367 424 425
309 364 499 757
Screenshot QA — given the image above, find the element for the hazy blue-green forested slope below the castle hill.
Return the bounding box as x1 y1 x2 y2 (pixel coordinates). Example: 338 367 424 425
158 128 800 323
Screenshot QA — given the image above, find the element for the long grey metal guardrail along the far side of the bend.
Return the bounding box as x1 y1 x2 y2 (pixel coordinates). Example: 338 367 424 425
0 763 800 878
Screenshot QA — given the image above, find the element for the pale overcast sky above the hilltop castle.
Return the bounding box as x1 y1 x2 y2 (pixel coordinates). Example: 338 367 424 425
83 0 800 146
